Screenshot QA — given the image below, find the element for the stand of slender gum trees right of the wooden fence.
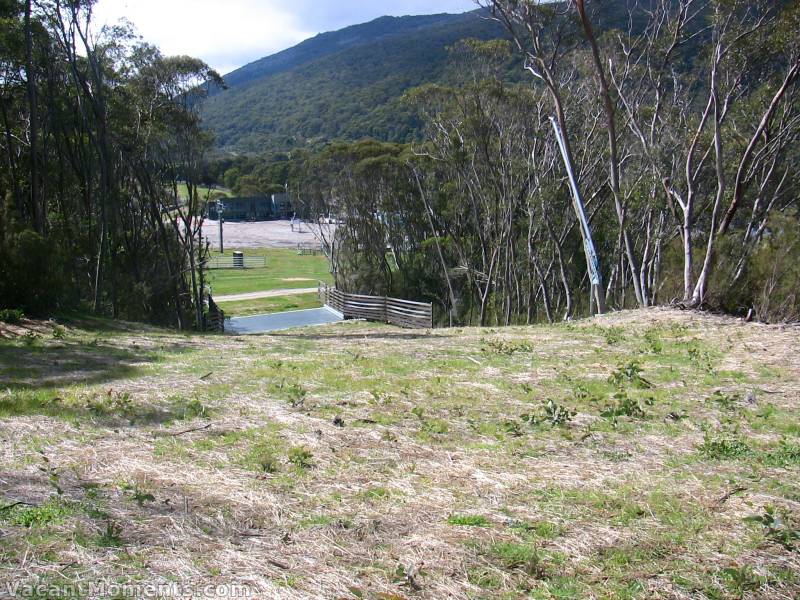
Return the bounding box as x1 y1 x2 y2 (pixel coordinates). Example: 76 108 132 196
292 0 800 324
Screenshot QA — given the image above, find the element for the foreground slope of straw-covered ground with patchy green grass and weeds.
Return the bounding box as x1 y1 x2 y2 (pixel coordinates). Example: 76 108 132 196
0 309 800 599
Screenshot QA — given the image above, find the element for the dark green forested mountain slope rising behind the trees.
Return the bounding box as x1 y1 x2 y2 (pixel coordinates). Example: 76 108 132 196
203 11 504 153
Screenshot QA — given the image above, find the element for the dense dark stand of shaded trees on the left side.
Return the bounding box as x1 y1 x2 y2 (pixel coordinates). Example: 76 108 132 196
0 0 222 328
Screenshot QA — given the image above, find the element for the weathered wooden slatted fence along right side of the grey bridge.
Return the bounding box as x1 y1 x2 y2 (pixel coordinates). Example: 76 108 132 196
319 283 433 329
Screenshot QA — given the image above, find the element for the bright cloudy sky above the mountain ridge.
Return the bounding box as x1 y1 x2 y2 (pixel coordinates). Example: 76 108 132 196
94 0 477 75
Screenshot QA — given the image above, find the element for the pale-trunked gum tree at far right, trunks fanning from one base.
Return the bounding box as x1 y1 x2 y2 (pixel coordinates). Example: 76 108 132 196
610 0 800 306
